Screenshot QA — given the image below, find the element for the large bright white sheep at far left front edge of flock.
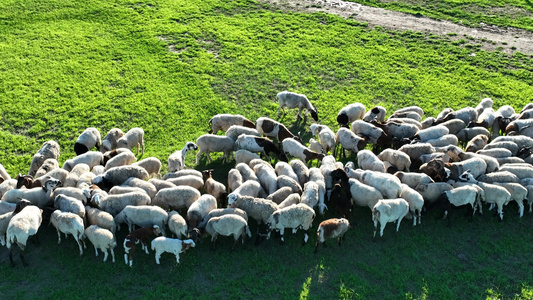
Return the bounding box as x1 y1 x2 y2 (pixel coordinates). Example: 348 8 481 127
6 205 43 267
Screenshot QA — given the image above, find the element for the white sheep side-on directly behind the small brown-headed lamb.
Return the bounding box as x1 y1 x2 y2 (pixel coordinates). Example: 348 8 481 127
115 205 168 235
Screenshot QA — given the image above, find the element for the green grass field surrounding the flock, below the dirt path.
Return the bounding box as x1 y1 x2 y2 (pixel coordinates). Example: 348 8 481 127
0 0 533 299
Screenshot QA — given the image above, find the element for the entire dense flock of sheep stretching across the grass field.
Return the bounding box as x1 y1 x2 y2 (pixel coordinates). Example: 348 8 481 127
0 91 533 266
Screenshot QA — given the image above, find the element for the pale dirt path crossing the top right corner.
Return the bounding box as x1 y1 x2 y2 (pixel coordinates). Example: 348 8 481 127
259 0 533 55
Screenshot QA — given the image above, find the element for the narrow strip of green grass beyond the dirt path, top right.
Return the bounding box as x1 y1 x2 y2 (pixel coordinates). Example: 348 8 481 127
352 0 533 31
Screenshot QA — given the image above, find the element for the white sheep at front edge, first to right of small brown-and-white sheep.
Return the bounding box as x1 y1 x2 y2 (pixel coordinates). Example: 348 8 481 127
372 198 409 237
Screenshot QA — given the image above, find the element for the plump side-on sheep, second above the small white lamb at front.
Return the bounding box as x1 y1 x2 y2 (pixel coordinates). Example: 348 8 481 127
152 186 200 210
